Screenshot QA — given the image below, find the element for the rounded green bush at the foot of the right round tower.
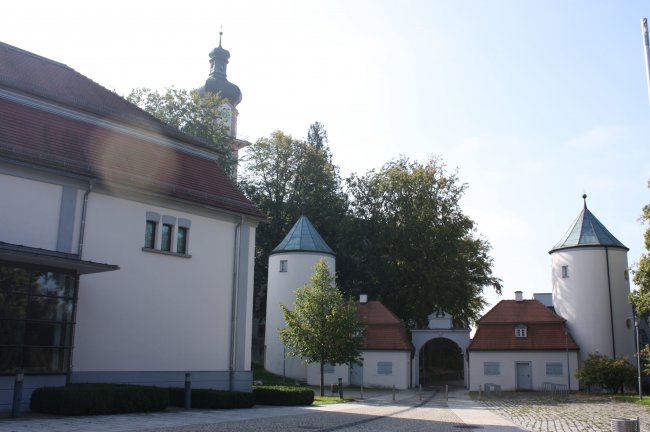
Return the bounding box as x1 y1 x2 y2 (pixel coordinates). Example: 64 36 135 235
576 353 636 393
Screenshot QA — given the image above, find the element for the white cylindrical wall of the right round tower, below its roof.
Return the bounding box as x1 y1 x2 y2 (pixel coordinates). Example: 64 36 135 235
551 247 634 360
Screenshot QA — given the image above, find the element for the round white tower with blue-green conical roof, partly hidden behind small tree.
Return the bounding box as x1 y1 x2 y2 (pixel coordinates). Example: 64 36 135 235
264 216 336 380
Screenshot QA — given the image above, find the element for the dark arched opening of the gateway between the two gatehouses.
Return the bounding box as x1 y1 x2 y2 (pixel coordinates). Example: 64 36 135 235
418 337 465 386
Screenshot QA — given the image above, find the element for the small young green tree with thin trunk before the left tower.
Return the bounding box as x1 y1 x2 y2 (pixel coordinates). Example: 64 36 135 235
279 259 363 396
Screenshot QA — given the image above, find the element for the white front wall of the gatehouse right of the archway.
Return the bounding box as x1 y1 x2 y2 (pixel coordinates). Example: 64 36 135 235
469 351 578 391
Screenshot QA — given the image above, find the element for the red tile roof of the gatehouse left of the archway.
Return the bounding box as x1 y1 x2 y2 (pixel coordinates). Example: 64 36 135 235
357 301 413 351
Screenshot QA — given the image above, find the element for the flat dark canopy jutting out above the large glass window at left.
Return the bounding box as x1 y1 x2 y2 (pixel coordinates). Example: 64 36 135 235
0 242 120 274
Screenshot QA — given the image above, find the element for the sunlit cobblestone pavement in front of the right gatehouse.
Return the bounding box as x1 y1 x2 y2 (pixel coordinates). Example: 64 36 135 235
482 393 650 432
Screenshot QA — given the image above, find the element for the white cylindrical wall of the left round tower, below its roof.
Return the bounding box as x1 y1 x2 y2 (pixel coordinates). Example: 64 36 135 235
264 252 336 380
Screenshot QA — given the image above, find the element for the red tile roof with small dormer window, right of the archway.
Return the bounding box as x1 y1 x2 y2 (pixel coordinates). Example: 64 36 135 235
468 300 580 351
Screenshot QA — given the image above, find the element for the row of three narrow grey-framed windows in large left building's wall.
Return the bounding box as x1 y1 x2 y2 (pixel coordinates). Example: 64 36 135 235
144 212 192 255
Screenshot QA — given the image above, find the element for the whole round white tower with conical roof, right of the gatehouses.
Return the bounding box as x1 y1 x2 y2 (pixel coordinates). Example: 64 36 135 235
549 195 635 361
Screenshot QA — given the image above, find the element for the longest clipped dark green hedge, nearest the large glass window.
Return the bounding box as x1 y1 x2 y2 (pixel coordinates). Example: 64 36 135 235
30 384 169 416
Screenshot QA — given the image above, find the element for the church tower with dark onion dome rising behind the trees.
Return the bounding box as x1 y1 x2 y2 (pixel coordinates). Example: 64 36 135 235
198 32 249 174
